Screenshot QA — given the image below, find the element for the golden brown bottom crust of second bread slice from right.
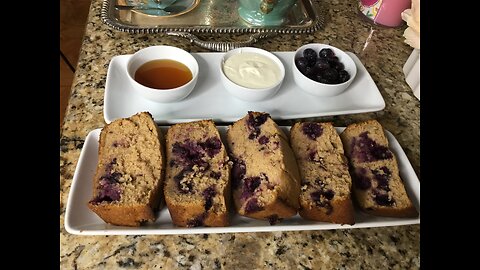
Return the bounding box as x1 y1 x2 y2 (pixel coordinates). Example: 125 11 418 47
299 197 355 225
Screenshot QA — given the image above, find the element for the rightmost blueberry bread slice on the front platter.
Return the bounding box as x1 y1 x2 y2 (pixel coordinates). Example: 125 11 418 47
340 120 418 217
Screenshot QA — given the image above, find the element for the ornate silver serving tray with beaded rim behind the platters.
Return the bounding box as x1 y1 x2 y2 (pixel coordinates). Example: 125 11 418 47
101 0 325 51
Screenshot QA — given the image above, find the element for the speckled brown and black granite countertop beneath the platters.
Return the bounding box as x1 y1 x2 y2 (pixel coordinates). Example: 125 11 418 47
60 0 420 269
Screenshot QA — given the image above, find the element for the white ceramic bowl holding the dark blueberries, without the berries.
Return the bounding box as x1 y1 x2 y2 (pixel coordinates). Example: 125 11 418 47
292 43 357 97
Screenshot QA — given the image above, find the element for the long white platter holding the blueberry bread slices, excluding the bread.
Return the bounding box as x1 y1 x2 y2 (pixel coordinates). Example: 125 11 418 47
65 126 420 235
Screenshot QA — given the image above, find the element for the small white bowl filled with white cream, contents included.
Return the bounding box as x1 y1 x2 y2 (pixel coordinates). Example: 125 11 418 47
220 47 285 101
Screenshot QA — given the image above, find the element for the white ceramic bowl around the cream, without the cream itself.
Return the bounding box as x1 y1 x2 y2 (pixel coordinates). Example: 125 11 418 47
219 47 285 101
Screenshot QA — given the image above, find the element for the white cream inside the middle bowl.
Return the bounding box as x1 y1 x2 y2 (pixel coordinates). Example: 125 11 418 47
223 52 281 89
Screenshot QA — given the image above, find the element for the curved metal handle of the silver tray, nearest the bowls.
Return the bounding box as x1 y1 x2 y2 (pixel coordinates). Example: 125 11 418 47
166 32 277 52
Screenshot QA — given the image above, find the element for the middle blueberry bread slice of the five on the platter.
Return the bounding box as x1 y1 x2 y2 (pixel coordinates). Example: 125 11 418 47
227 112 300 224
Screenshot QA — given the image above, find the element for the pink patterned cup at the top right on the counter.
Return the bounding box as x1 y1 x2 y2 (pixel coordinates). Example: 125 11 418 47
358 0 412 27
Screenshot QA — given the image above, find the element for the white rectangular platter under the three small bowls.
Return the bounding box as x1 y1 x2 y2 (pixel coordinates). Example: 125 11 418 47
104 52 385 124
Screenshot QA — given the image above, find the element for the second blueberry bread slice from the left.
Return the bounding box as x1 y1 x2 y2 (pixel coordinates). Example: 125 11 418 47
165 120 231 227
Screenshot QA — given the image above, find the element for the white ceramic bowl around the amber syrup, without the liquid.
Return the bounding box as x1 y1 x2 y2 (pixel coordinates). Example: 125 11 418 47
127 45 198 103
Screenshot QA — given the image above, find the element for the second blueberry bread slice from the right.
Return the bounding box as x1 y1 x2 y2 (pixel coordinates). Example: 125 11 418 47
290 122 355 224
